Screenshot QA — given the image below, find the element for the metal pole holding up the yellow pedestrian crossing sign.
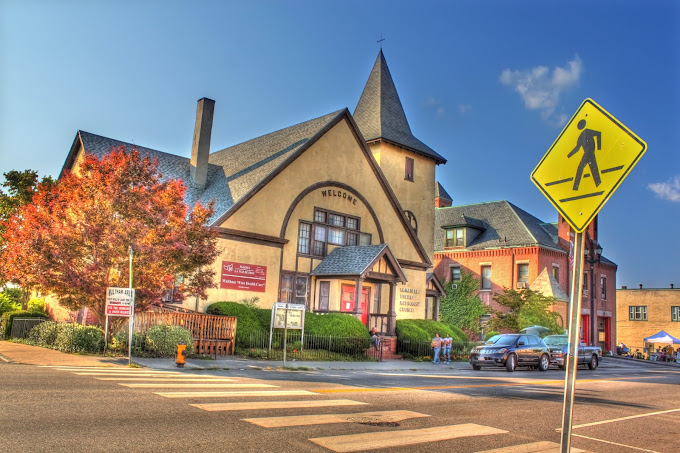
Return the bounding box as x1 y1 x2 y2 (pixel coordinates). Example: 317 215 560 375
560 233 592 453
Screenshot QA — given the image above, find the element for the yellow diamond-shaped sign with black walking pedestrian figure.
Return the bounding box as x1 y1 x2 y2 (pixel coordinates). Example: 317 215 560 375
531 99 647 233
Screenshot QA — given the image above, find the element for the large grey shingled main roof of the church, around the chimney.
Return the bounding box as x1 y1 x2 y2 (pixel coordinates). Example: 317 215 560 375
62 109 348 225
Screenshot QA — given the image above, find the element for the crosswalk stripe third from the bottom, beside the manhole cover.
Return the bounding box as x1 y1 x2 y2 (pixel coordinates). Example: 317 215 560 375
243 411 430 428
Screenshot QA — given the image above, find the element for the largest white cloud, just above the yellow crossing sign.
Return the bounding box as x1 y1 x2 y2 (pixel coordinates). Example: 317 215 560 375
499 55 583 123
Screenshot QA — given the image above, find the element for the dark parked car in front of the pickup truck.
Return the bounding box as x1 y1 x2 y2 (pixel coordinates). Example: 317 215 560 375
470 333 550 372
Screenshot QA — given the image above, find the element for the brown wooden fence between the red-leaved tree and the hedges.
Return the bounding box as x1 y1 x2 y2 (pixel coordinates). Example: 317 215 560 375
135 312 236 355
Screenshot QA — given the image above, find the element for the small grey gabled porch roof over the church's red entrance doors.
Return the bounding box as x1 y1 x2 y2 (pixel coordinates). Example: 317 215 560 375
309 244 407 283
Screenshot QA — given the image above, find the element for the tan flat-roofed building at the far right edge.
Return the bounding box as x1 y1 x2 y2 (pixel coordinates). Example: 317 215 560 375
616 285 680 351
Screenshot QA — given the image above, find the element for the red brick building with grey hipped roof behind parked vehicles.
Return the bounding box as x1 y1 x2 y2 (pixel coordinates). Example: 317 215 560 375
433 198 617 350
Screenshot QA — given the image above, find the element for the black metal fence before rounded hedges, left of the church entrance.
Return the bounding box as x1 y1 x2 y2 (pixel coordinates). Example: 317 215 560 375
236 330 382 361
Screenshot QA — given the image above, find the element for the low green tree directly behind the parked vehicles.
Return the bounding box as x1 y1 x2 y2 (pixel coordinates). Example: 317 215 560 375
489 289 564 333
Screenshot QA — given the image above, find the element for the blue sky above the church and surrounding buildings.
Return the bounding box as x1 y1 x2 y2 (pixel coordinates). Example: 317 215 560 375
0 0 680 287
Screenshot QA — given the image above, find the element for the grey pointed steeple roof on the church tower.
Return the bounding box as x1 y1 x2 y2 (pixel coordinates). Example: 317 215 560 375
354 49 446 164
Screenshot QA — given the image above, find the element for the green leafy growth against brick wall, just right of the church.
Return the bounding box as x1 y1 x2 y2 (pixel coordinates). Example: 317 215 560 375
439 272 489 335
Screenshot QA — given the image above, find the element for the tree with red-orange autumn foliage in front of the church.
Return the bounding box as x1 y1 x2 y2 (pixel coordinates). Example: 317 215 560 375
0 147 218 324
